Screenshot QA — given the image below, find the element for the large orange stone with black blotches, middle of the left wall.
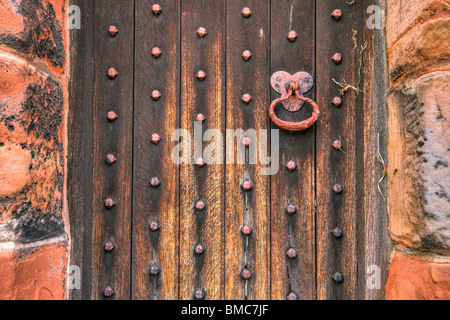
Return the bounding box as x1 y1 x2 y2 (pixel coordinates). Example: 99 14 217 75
0 55 64 243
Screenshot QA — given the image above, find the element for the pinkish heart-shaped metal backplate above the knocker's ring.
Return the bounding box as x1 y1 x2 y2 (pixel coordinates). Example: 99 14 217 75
270 71 314 112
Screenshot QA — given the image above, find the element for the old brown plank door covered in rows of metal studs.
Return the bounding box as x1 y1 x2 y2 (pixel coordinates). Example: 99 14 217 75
68 0 389 300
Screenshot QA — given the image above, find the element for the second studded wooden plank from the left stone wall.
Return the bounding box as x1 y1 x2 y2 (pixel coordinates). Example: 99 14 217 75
132 0 180 300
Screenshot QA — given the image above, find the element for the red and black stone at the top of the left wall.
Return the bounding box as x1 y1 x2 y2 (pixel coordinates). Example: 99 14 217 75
0 0 66 72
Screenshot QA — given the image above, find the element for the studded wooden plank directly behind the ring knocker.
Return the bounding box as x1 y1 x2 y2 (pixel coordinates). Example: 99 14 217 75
267 0 316 300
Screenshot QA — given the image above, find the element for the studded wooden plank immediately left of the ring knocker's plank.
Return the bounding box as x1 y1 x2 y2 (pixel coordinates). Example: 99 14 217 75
225 0 270 300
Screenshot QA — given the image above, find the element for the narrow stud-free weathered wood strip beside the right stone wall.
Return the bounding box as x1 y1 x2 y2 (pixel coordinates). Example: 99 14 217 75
357 0 392 300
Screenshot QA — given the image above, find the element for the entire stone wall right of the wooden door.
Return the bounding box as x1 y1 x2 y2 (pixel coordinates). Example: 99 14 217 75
386 0 450 299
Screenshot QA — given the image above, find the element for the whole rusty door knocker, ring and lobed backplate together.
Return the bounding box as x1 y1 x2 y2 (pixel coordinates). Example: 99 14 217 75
269 71 320 131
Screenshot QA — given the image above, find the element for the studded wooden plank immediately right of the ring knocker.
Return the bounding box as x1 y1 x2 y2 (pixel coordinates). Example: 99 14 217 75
316 0 364 299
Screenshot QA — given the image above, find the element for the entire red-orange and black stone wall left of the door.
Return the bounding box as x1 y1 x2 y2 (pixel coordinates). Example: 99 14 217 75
0 0 67 300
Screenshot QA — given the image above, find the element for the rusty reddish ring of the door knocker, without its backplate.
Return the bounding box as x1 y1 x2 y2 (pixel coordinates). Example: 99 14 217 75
269 82 320 132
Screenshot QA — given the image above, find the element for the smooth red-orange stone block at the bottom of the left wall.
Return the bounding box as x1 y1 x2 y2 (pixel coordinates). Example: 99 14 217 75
0 242 67 300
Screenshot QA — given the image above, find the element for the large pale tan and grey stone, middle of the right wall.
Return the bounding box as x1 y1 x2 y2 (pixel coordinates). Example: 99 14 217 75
388 72 450 254
